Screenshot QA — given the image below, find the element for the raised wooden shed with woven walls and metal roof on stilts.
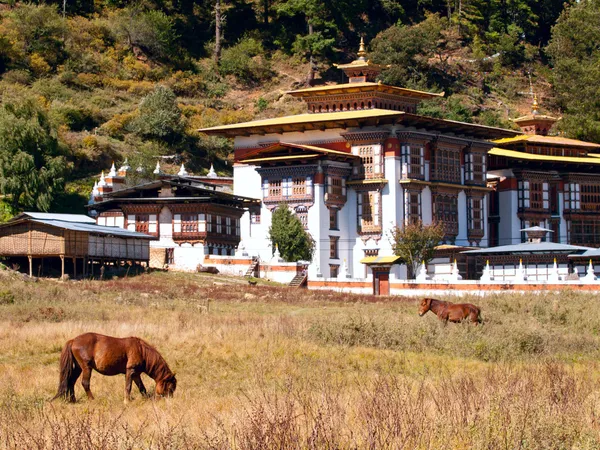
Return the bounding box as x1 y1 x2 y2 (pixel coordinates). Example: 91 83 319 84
0 213 155 276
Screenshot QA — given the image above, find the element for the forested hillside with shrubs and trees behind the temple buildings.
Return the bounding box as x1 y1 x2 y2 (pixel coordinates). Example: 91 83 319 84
0 0 600 217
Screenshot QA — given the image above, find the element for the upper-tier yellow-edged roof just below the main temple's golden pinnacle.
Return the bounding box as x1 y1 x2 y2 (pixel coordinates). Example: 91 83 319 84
287 81 445 99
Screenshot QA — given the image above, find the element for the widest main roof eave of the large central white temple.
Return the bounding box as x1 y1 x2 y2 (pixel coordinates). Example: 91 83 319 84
198 108 522 139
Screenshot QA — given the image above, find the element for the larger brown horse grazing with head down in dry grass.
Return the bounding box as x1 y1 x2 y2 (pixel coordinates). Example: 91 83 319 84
52 333 177 403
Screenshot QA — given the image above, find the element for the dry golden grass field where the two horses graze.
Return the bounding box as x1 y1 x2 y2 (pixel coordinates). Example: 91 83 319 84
0 272 600 450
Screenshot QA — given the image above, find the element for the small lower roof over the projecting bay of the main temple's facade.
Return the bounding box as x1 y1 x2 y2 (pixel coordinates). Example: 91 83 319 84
237 142 359 164
